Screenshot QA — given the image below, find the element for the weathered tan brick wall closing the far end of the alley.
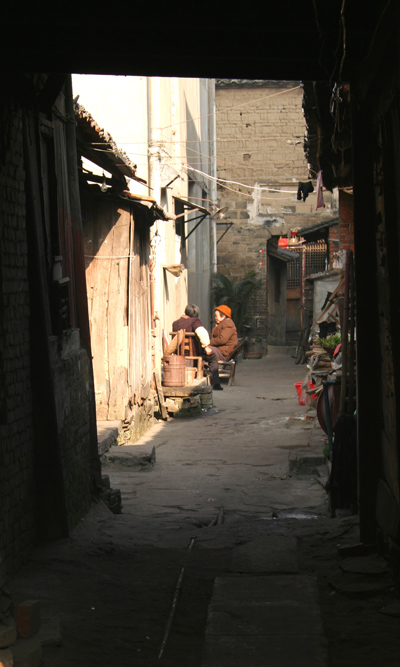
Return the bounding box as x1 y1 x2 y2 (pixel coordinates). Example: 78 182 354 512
216 82 336 339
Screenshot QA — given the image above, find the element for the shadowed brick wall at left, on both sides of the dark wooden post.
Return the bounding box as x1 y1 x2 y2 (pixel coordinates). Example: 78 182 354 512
0 90 93 575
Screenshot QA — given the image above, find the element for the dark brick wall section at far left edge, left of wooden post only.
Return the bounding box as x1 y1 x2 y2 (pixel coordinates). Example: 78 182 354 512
0 102 35 569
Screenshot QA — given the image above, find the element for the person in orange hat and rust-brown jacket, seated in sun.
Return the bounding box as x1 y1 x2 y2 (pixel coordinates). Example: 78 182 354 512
204 304 237 391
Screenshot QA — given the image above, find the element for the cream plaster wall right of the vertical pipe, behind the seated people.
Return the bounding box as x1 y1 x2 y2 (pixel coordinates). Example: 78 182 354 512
145 77 214 350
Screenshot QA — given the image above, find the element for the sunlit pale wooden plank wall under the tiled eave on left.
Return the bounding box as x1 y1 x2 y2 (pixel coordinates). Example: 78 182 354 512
82 193 152 420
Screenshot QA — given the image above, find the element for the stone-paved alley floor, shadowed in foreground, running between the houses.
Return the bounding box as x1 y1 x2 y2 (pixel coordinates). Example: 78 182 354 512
9 349 400 667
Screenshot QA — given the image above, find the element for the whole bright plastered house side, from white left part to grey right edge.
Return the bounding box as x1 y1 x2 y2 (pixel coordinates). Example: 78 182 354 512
73 75 213 354
